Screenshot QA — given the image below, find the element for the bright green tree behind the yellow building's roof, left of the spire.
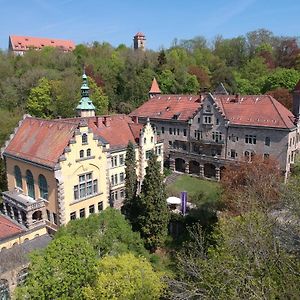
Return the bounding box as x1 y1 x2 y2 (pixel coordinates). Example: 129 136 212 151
26 78 54 118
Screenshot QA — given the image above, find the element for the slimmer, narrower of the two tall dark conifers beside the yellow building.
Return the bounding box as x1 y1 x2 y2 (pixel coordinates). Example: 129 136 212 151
122 141 138 227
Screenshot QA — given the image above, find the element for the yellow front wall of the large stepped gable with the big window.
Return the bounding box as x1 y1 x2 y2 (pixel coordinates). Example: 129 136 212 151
56 127 109 224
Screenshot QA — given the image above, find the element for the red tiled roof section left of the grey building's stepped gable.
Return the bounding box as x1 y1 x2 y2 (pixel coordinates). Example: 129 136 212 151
130 95 200 121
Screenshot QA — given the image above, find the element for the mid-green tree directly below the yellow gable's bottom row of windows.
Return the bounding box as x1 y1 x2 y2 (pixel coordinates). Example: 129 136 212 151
56 208 148 257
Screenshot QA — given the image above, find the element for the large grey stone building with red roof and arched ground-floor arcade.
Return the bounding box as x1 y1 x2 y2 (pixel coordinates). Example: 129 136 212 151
130 80 300 180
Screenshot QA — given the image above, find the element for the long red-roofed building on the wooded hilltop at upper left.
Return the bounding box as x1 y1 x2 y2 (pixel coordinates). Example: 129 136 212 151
8 35 75 55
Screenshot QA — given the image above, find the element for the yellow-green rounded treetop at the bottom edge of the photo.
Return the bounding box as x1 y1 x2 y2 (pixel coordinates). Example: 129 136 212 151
84 253 164 300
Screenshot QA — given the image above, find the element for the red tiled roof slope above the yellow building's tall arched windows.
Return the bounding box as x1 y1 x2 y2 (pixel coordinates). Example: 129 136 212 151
4 117 78 168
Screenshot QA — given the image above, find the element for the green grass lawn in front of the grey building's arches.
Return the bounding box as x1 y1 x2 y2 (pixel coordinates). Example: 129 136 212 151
167 175 221 206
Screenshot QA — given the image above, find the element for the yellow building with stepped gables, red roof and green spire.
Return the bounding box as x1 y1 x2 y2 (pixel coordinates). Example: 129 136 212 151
0 74 163 239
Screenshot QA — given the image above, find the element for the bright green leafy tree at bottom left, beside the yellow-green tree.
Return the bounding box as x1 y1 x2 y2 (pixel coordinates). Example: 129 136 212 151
16 236 97 300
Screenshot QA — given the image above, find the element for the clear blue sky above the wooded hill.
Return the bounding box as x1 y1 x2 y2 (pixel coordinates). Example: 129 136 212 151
0 0 300 50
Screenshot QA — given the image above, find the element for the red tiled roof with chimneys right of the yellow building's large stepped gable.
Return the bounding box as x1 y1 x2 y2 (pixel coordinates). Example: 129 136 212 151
87 115 143 149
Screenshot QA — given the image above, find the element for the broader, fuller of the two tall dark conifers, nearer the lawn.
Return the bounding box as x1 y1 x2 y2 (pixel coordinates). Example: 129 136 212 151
136 153 170 252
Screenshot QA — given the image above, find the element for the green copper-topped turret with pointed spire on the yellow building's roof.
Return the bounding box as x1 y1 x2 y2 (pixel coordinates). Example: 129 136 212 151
76 72 95 118
